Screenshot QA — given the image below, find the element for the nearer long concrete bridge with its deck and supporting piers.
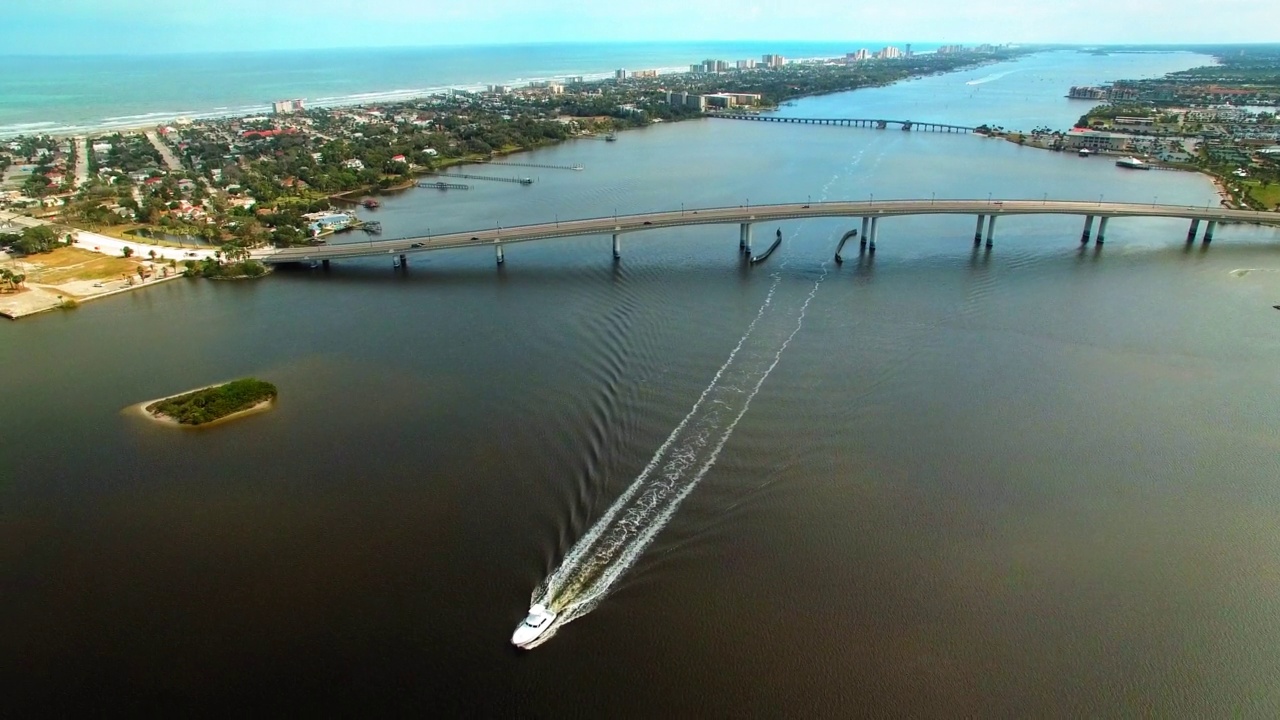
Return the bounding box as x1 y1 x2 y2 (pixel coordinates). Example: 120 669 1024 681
255 199 1280 264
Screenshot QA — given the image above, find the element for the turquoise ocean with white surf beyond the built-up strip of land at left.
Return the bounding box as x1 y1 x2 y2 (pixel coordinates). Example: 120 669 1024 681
0 42 911 137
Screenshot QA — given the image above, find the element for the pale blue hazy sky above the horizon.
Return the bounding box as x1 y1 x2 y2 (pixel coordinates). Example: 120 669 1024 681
0 0 1280 54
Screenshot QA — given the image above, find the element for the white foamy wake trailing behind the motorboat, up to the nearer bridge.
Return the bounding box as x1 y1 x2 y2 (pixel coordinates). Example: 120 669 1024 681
522 206 828 648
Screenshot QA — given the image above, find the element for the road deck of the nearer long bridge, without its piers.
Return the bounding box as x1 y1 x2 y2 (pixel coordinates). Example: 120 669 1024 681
255 200 1280 263
